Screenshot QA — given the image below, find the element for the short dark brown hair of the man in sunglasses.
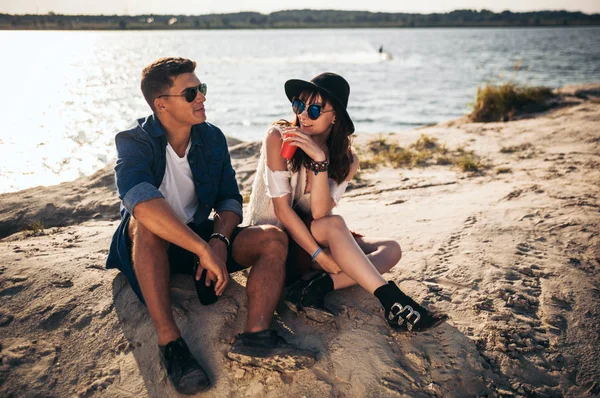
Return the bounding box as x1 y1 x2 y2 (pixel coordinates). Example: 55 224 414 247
141 57 196 112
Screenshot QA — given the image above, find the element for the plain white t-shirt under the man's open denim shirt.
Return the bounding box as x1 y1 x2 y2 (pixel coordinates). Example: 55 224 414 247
158 140 198 224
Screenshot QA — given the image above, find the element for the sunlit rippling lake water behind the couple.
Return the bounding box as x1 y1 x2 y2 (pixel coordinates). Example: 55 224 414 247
0 27 600 193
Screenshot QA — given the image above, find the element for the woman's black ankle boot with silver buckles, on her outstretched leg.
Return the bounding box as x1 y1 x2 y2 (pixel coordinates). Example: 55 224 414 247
373 281 448 332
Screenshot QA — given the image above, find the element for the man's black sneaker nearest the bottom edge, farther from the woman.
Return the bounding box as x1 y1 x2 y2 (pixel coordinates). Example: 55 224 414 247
158 337 210 395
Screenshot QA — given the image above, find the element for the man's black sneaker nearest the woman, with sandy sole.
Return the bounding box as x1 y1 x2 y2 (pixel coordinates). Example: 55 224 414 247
227 330 315 372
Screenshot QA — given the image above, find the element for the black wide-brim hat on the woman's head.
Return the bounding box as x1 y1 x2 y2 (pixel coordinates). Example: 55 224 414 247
285 72 354 135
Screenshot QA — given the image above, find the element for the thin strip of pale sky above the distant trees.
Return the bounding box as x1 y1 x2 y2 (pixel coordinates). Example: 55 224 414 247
0 0 600 15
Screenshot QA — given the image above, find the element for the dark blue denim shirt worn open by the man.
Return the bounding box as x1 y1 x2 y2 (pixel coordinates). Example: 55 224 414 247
107 115 242 268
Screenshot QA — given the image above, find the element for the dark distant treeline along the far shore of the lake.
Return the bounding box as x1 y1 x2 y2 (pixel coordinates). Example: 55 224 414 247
0 10 600 30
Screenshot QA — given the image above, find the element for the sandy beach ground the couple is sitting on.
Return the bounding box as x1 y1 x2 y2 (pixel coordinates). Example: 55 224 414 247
0 85 600 397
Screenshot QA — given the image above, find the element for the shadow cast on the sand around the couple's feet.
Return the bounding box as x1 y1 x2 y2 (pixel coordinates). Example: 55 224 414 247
113 274 506 397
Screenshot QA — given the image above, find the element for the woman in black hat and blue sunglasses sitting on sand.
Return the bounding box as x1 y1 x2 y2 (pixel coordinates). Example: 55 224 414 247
248 73 447 331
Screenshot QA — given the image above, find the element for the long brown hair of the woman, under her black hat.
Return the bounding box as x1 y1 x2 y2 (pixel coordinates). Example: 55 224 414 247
273 92 353 184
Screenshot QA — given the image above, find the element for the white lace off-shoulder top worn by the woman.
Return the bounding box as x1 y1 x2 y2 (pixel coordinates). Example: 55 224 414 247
244 126 348 228
